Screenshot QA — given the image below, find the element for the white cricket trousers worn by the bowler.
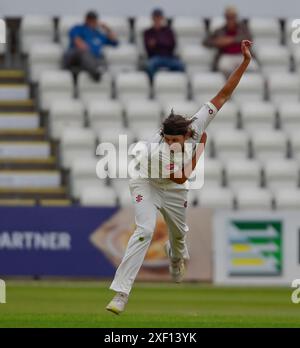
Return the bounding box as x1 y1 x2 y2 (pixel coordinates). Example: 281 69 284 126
110 179 189 294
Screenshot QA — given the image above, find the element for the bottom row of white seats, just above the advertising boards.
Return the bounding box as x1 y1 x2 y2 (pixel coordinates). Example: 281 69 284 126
79 177 300 210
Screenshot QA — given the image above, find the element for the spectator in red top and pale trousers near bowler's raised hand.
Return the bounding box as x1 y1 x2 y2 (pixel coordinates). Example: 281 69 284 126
203 6 258 75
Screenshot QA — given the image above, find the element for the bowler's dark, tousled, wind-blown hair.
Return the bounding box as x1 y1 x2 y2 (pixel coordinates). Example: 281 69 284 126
160 109 197 138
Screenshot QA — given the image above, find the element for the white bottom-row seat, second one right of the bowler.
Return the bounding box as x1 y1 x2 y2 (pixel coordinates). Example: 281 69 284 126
236 187 272 211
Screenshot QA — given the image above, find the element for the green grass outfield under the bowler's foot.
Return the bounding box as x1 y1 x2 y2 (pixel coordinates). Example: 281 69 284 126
0 280 300 328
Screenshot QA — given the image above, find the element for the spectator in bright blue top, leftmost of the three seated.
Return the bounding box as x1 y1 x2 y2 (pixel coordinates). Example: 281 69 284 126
64 11 118 81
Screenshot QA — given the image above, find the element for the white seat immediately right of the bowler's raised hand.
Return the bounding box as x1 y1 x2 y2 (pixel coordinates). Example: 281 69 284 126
255 45 291 74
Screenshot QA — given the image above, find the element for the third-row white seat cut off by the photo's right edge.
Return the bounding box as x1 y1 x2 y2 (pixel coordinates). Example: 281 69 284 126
267 73 300 105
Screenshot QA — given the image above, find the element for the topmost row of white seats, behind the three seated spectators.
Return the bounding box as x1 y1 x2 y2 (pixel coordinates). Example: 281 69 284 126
20 15 294 53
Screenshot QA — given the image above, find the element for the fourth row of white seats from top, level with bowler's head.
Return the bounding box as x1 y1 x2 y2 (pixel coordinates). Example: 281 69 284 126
49 99 300 143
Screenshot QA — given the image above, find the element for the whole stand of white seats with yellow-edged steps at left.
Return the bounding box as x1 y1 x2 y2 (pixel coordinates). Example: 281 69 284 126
0 16 300 209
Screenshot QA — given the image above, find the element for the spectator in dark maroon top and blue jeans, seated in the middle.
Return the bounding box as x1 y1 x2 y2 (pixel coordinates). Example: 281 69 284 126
144 9 184 79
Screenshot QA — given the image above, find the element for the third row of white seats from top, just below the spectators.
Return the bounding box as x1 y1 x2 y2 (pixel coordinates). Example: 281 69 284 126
38 70 300 110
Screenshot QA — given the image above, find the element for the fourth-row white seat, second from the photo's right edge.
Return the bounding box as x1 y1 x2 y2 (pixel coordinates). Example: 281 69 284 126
240 101 276 130
